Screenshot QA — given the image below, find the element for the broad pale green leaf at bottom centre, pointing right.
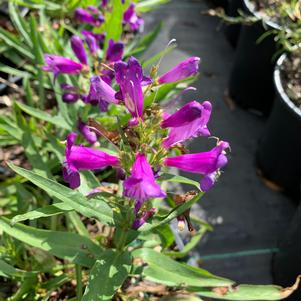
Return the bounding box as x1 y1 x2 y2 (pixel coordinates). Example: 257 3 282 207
132 248 234 287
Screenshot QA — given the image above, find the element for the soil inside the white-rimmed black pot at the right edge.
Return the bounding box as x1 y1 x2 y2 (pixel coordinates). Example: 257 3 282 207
281 49 301 109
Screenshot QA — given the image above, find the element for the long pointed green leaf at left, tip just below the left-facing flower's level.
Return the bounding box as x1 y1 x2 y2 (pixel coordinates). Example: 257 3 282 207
9 163 114 224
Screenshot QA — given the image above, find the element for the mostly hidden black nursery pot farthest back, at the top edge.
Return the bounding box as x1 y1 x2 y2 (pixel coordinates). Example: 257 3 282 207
224 0 244 48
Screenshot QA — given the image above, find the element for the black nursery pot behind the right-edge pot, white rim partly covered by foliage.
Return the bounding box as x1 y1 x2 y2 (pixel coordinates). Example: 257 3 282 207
229 0 279 115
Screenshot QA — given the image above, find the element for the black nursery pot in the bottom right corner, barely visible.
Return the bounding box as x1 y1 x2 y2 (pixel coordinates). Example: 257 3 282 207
272 200 301 301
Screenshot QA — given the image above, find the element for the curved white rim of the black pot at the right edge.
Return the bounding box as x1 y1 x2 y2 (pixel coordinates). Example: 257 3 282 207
274 53 301 118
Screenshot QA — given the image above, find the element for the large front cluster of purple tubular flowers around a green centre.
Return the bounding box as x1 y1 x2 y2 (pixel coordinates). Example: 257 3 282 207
51 52 229 228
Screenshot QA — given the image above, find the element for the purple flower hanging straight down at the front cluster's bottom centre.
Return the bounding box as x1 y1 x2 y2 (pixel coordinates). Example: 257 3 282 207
123 154 166 214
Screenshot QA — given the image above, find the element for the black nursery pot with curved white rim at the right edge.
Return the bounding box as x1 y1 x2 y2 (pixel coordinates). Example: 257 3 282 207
256 55 301 199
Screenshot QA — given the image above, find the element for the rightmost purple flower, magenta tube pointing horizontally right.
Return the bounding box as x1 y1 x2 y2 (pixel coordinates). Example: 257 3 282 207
164 141 229 191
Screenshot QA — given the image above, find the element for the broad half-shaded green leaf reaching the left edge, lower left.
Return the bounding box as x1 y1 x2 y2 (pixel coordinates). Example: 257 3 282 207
0 217 102 267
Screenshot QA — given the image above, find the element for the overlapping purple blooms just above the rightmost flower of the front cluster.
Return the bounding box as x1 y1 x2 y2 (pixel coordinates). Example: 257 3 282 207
161 101 212 148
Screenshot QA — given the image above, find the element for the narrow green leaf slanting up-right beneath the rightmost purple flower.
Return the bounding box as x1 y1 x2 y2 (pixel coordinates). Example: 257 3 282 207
138 192 204 232
